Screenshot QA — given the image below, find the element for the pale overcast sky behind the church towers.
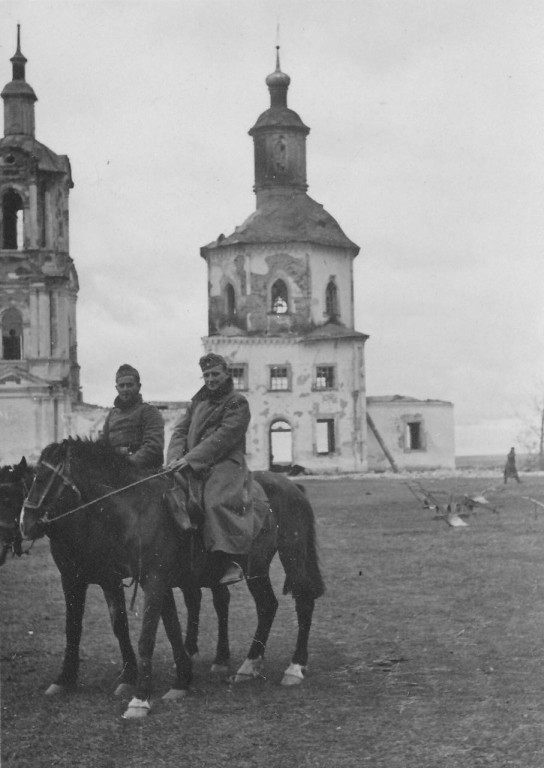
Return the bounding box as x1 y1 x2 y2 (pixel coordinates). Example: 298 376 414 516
0 0 544 454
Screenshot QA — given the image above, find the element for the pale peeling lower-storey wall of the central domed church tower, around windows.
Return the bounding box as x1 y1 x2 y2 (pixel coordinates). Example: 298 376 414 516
204 336 367 473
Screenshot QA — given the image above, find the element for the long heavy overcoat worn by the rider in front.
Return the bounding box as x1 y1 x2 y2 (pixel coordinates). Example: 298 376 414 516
166 381 254 555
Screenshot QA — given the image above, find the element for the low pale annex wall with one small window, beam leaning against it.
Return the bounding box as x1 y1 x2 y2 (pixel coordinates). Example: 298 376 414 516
367 397 455 471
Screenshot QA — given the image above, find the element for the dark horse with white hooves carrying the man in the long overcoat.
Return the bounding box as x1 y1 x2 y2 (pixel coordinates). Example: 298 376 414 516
21 440 324 717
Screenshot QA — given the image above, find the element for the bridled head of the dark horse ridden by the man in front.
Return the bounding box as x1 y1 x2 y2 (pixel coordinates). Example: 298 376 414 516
20 438 81 540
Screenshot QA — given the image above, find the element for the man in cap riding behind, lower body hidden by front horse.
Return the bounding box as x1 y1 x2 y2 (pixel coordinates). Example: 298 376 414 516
102 363 164 469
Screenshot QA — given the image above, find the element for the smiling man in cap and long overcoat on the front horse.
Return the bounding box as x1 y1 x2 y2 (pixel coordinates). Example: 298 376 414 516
166 352 254 584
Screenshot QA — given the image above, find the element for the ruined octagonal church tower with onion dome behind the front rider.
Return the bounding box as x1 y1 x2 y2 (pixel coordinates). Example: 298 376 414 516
201 50 367 472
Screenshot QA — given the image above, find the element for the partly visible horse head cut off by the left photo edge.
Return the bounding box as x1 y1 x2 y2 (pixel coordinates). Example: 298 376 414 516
0 456 34 566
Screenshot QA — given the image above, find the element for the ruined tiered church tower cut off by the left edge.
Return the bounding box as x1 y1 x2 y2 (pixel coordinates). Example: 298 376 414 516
0 28 80 461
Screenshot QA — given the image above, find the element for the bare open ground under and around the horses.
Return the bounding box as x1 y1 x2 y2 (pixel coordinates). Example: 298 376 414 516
0 474 544 768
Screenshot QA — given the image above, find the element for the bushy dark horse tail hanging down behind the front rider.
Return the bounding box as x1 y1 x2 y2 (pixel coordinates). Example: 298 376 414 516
254 472 325 599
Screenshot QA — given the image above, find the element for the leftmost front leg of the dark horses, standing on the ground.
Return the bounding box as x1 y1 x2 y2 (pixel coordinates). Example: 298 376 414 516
45 574 88 696
